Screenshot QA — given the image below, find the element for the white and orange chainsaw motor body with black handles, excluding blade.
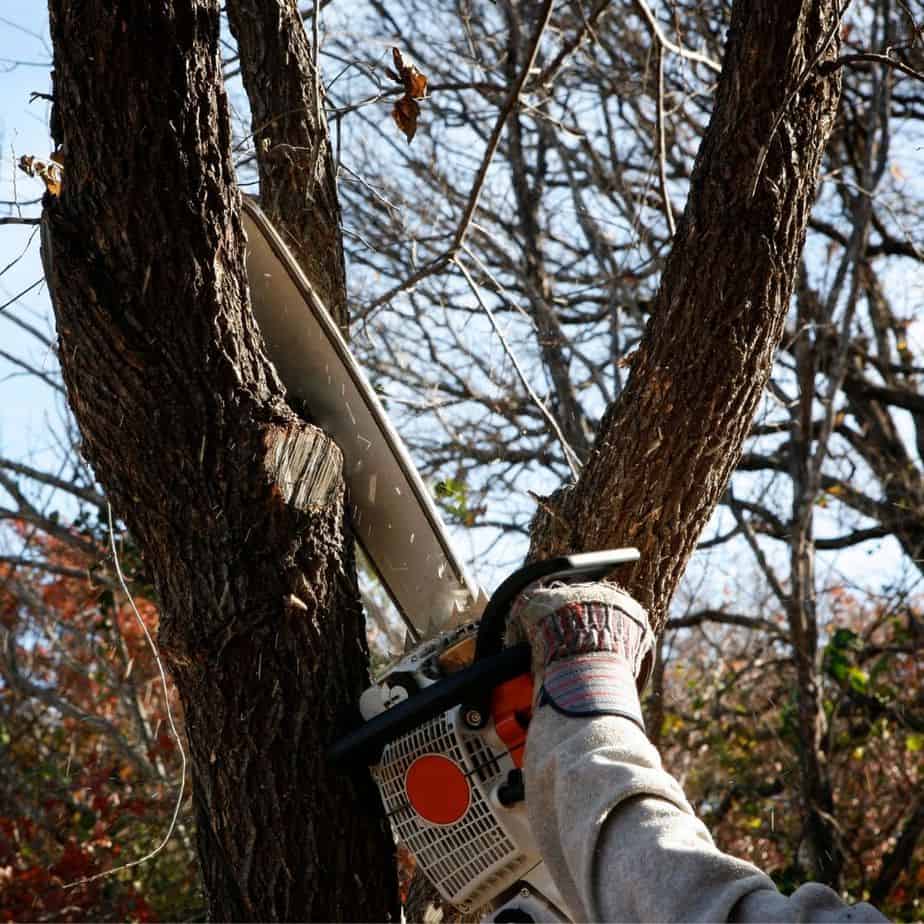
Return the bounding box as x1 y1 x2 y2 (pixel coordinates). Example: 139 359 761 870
331 549 638 922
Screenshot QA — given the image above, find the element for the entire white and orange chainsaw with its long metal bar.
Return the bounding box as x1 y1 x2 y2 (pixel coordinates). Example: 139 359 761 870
244 200 639 922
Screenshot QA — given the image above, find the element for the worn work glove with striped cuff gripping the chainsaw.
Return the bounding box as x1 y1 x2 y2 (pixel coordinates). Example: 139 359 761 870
507 582 655 730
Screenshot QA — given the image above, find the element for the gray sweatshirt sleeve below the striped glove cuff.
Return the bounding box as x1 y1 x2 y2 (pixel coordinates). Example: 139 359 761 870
524 706 886 922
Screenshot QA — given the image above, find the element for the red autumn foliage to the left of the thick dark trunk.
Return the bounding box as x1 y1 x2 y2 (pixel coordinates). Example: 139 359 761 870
0 526 203 921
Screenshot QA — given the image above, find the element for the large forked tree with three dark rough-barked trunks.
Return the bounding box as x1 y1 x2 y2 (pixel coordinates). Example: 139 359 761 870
43 0 841 920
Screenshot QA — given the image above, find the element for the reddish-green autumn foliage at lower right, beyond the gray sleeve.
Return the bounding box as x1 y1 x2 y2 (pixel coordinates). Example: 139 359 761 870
661 589 924 920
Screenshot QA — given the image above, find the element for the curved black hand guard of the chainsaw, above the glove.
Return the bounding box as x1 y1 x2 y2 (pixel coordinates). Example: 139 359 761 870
462 548 641 728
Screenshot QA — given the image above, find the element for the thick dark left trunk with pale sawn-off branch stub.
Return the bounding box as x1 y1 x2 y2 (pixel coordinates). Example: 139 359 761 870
44 0 396 920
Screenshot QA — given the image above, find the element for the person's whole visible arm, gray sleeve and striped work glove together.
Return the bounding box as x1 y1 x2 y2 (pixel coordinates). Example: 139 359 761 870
517 585 886 922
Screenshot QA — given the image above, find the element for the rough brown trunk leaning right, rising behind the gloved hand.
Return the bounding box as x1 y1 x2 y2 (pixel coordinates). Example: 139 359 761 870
530 0 840 630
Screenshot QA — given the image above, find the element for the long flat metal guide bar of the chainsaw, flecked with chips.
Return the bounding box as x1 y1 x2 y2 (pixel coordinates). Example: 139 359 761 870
243 199 486 640
